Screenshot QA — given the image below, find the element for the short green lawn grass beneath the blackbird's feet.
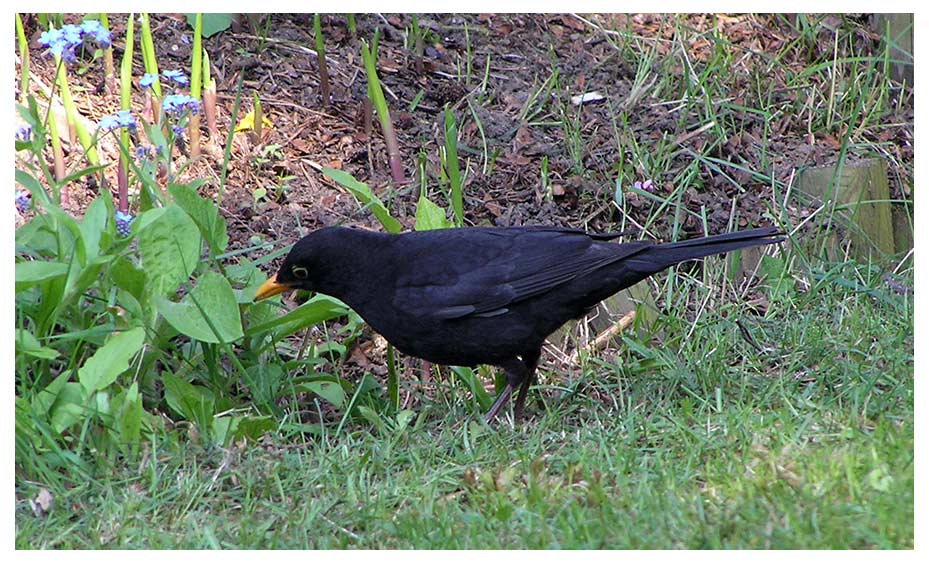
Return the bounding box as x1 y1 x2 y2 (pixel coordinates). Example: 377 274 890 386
16 258 913 549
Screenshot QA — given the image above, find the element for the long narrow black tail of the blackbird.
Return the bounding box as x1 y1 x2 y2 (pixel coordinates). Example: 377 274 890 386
626 227 784 272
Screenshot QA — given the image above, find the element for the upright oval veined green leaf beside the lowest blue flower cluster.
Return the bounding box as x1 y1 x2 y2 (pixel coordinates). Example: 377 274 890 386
139 205 201 296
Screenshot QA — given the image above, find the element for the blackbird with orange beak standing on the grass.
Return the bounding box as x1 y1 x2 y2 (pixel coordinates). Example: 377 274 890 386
255 227 784 422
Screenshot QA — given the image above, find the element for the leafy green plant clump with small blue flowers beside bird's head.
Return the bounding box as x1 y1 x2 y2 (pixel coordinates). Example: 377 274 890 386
15 17 360 472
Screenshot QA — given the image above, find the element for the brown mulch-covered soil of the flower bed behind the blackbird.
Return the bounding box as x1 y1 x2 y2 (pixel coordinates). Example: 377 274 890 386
16 14 913 268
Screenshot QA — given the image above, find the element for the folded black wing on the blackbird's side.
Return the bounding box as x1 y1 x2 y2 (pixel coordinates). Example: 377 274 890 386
394 228 651 319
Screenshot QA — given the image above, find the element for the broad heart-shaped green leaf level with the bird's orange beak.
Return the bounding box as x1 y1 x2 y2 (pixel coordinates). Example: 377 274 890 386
155 272 242 343
